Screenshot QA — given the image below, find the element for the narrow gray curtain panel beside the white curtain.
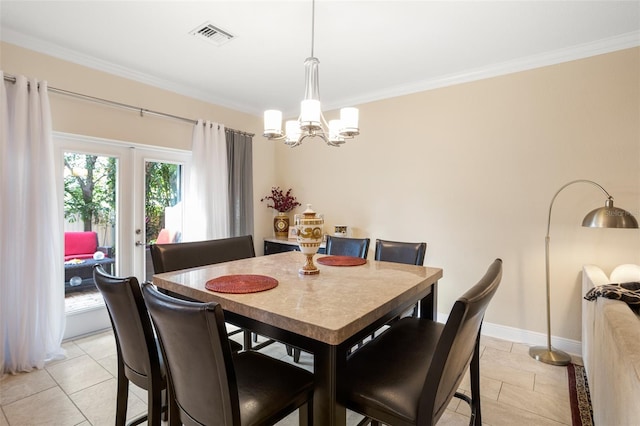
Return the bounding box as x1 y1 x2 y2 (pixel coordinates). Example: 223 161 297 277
226 129 253 237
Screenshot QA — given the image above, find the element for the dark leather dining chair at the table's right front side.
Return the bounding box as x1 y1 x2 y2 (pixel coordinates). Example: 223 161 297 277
338 259 502 426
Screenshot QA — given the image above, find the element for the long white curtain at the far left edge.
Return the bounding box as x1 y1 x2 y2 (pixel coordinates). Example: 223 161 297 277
0 71 65 374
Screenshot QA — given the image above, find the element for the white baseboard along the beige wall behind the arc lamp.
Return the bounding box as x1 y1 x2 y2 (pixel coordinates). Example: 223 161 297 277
438 312 582 357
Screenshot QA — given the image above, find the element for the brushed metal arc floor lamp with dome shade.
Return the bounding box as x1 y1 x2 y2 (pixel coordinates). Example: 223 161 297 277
529 179 638 365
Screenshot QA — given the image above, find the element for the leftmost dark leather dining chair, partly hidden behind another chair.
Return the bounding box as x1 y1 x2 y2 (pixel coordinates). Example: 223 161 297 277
93 265 172 426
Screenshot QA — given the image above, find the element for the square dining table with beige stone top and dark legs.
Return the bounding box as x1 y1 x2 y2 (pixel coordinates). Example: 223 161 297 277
153 252 443 426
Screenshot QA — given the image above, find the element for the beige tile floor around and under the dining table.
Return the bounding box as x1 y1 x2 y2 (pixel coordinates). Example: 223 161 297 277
0 324 579 426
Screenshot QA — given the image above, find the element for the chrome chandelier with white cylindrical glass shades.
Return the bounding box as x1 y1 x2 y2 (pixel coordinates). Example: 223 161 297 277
263 0 360 148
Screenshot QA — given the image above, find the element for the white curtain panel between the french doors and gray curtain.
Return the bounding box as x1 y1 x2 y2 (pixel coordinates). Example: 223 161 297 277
183 120 230 241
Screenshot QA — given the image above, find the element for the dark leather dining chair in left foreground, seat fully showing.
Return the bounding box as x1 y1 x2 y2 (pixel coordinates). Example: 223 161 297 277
142 283 314 425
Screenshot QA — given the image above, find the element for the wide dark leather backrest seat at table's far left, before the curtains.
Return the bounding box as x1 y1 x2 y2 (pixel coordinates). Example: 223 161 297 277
149 235 273 350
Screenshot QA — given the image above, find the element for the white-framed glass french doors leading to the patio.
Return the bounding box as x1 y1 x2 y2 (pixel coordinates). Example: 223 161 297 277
54 133 191 292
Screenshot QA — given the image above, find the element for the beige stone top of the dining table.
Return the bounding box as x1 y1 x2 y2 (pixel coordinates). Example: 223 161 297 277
153 252 442 345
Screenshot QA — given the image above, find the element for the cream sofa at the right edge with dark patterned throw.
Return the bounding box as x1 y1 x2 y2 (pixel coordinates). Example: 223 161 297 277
582 264 640 426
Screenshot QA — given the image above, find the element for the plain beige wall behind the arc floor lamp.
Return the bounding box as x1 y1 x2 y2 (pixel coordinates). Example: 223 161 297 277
270 49 640 343
